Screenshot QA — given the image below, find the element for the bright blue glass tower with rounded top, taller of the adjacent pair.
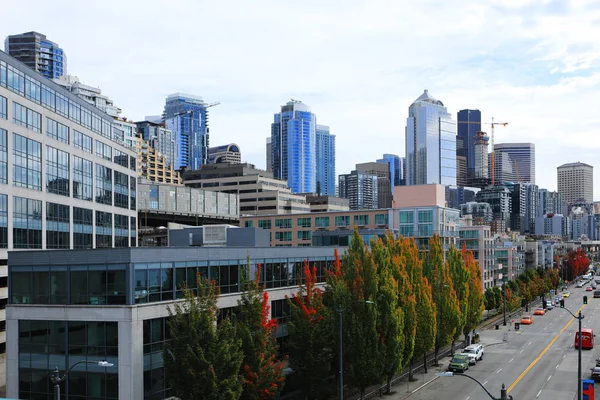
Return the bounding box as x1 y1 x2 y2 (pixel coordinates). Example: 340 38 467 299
271 100 317 193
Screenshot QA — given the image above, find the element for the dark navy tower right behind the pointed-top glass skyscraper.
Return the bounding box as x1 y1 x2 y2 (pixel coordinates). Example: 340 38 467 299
456 109 481 185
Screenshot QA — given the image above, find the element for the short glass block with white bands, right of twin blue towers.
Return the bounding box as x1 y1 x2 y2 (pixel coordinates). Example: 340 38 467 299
338 171 379 210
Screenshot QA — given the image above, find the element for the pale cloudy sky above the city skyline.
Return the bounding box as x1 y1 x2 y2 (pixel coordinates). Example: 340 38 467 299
0 0 600 200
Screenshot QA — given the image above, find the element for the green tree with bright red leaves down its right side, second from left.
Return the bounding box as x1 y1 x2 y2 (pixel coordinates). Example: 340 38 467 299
234 264 285 400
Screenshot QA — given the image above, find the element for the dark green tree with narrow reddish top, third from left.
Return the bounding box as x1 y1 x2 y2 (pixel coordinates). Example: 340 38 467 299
287 260 333 400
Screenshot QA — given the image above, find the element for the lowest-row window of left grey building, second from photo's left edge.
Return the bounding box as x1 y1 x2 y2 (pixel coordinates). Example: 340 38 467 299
13 196 42 249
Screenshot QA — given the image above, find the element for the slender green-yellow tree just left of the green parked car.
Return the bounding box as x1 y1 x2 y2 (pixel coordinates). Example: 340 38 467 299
423 234 462 365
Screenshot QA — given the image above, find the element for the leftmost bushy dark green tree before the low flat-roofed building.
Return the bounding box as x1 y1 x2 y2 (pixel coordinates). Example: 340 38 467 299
163 275 244 400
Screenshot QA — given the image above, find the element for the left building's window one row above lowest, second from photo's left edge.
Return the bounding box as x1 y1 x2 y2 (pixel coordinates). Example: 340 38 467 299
13 133 42 191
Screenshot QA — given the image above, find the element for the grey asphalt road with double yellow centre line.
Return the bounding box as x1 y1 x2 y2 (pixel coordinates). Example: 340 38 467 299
402 287 600 400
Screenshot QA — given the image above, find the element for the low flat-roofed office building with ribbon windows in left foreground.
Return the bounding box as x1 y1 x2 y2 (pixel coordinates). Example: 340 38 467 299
6 247 343 400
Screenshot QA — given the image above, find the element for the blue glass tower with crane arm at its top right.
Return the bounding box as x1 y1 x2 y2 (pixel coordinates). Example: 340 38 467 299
163 93 214 170
